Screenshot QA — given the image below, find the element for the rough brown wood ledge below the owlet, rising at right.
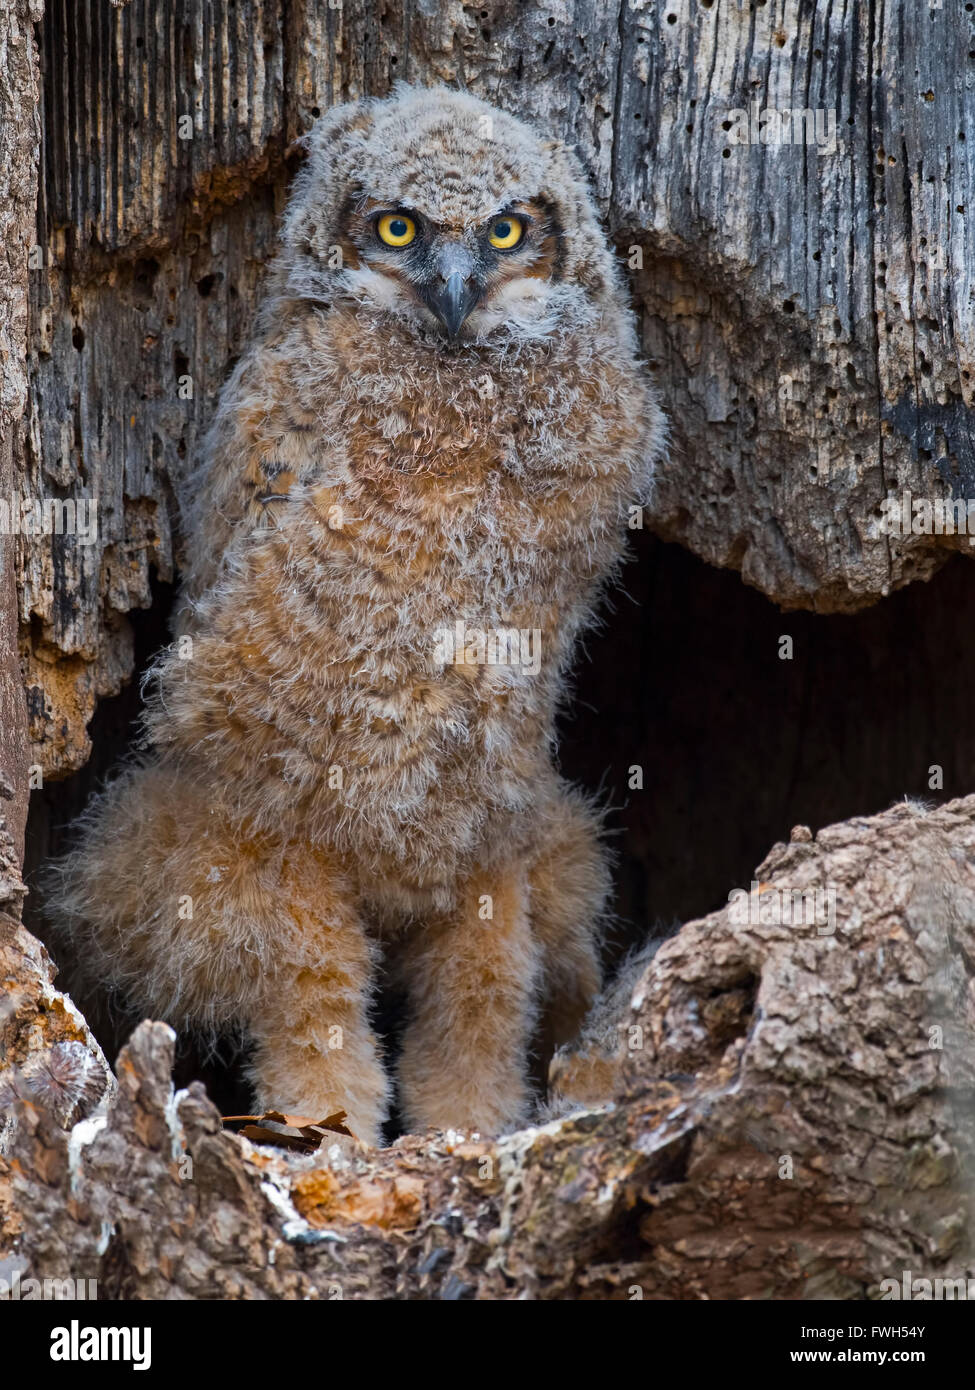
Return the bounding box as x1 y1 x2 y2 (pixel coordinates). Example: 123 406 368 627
0 796 975 1300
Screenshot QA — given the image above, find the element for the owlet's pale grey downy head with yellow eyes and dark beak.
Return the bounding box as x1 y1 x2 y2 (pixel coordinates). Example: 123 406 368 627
277 85 616 346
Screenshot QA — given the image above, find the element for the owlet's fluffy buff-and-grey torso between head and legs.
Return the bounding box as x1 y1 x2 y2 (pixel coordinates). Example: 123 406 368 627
161 278 659 895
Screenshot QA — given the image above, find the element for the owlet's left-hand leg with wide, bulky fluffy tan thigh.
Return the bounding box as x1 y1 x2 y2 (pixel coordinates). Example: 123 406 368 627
50 763 388 1141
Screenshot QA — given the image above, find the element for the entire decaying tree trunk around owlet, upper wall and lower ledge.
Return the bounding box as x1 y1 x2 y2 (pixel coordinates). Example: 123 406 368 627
0 0 975 1298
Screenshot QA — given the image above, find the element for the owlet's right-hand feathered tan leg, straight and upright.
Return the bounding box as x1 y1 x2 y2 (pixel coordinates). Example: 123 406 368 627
399 866 538 1134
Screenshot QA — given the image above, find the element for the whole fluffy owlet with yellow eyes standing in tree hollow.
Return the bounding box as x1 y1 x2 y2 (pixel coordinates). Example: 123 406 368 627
51 86 665 1144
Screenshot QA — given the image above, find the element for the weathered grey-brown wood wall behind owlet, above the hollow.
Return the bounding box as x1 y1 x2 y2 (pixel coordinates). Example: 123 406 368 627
19 0 975 776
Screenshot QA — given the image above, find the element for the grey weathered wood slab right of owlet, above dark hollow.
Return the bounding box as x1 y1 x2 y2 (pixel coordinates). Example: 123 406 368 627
623 0 975 612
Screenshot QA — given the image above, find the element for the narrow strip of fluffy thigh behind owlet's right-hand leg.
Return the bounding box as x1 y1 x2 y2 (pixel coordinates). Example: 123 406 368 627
529 791 611 1061
